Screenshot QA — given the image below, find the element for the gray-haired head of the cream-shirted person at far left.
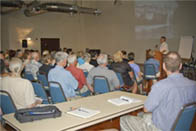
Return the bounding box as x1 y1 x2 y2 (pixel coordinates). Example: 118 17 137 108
9 57 23 75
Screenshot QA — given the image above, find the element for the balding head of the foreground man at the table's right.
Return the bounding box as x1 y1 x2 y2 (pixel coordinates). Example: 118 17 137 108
164 51 182 73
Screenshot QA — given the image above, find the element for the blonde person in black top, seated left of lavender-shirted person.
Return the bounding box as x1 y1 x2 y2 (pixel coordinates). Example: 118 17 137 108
111 51 137 93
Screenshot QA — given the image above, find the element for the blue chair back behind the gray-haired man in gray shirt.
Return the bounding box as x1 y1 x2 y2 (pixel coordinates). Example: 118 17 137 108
93 76 110 94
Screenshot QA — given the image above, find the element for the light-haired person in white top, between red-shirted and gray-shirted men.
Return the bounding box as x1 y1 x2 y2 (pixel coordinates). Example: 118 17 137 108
79 53 94 72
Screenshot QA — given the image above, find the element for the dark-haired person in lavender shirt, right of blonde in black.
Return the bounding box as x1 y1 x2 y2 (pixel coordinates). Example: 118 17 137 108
128 52 143 82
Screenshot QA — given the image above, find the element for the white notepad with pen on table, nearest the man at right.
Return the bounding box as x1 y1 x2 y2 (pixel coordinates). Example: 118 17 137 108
108 96 141 106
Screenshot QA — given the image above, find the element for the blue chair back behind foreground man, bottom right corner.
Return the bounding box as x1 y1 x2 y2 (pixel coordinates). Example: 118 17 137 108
172 102 196 131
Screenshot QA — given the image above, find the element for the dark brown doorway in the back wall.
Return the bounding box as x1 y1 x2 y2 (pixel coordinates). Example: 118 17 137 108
40 38 60 53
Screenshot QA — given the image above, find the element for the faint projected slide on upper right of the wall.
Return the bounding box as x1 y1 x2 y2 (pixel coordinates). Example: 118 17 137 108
135 1 178 39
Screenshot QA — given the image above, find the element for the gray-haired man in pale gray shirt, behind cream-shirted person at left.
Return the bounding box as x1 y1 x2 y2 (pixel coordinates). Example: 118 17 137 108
25 52 42 79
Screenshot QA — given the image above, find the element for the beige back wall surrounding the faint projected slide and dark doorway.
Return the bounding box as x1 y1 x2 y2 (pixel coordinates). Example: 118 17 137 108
1 1 196 63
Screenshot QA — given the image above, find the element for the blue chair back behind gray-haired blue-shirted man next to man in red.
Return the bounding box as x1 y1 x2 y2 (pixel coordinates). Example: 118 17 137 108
49 81 67 104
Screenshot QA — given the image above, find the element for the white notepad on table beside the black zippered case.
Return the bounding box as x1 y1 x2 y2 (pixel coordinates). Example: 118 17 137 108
67 107 100 118
